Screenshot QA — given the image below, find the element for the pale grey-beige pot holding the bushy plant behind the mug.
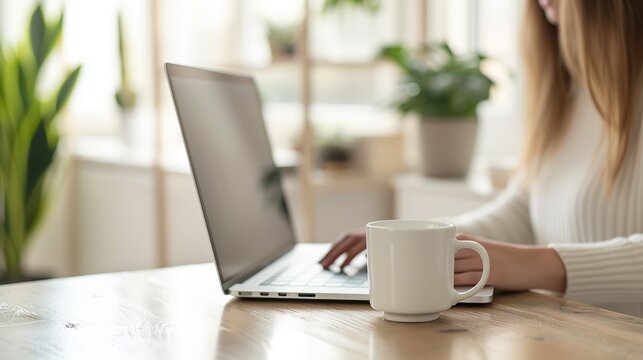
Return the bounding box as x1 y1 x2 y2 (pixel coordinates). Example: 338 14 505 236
419 118 478 178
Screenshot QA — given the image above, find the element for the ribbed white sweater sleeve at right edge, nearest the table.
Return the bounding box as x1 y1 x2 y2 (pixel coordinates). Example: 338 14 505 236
549 234 643 303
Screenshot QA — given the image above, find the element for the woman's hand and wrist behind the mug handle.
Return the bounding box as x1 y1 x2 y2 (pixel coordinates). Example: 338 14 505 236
453 234 567 293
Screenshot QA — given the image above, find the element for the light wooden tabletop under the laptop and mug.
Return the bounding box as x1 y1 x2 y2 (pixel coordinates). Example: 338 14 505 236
0 264 643 360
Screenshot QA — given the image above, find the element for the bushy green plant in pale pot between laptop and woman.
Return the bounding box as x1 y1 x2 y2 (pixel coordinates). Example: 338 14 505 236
381 43 494 177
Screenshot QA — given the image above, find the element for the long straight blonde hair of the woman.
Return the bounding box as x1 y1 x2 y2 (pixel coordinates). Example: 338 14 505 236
522 0 643 189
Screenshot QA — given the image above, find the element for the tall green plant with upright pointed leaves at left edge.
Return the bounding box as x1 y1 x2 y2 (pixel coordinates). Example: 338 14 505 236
0 5 80 282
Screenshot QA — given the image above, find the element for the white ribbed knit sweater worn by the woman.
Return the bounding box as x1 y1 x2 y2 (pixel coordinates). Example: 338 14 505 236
453 91 643 316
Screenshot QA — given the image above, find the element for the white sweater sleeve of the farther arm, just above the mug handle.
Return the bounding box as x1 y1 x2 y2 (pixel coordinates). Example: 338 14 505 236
449 182 534 244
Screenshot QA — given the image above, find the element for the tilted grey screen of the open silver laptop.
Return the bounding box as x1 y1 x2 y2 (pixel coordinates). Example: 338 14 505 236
167 64 295 291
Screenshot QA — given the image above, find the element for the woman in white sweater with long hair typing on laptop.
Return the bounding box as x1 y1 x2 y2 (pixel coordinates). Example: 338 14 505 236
320 0 643 316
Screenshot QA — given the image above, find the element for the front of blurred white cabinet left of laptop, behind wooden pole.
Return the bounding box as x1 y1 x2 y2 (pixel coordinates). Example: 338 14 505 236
72 161 214 274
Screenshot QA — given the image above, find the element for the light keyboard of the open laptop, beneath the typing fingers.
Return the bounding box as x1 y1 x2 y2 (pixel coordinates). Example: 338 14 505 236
261 264 368 288
